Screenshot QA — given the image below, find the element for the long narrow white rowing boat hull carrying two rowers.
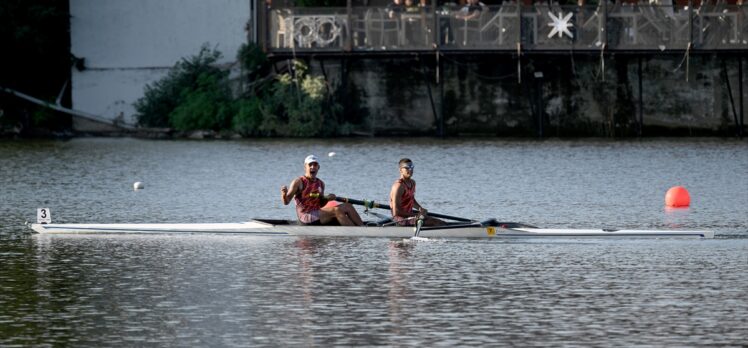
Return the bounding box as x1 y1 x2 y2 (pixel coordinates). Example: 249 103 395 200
31 220 714 239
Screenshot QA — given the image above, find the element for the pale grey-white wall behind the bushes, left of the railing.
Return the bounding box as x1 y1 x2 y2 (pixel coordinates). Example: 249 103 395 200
70 0 251 123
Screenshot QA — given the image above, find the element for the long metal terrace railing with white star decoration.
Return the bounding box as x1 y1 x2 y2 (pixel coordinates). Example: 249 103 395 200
264 1 748 53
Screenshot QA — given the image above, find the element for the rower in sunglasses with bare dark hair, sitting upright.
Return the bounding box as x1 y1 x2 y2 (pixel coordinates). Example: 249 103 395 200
390 158 444 226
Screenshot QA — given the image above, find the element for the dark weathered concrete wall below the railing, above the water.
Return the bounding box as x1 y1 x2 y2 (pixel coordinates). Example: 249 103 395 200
330 54 748 136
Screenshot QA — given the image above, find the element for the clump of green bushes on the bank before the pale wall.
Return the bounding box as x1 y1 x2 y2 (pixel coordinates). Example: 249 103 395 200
135 44 350 137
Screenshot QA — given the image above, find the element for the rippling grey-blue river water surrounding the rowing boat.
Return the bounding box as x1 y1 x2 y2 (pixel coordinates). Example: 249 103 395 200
0 138 748 346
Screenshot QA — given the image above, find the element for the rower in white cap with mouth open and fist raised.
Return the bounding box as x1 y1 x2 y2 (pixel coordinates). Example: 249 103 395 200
281 155 364 226
